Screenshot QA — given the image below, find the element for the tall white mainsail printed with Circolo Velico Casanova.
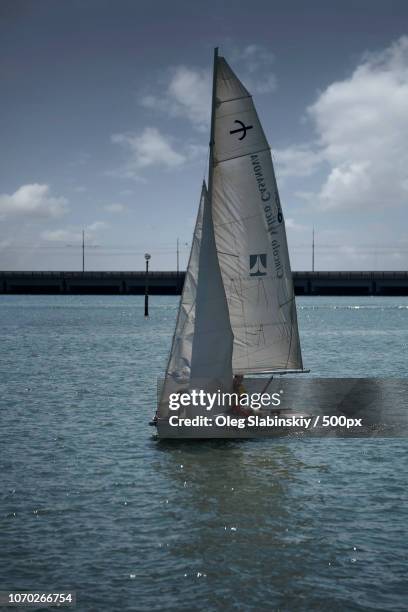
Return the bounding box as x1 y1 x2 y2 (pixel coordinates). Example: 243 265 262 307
212 58 303 374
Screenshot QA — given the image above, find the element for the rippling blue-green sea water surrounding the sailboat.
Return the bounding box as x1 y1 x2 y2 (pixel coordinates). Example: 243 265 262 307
0 296 408 612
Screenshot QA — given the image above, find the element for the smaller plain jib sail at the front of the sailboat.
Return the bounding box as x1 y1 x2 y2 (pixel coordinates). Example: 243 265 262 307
159 183 233 417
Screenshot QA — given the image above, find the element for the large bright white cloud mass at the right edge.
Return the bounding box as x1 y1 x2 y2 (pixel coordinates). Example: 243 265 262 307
308 36 408 209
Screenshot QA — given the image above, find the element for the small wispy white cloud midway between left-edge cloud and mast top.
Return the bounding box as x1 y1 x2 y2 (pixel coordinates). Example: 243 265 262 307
112 127 186 178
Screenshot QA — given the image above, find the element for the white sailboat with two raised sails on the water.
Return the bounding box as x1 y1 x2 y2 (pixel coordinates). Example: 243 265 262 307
154 49 305 438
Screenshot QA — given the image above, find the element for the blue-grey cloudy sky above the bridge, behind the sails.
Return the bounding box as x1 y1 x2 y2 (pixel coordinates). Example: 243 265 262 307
0 0 408 270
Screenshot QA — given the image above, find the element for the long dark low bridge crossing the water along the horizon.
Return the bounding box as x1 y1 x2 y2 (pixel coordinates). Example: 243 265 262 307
0 271 408 295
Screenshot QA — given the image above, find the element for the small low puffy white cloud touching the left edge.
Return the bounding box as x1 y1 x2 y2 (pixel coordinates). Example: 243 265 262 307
0 183 68 217
